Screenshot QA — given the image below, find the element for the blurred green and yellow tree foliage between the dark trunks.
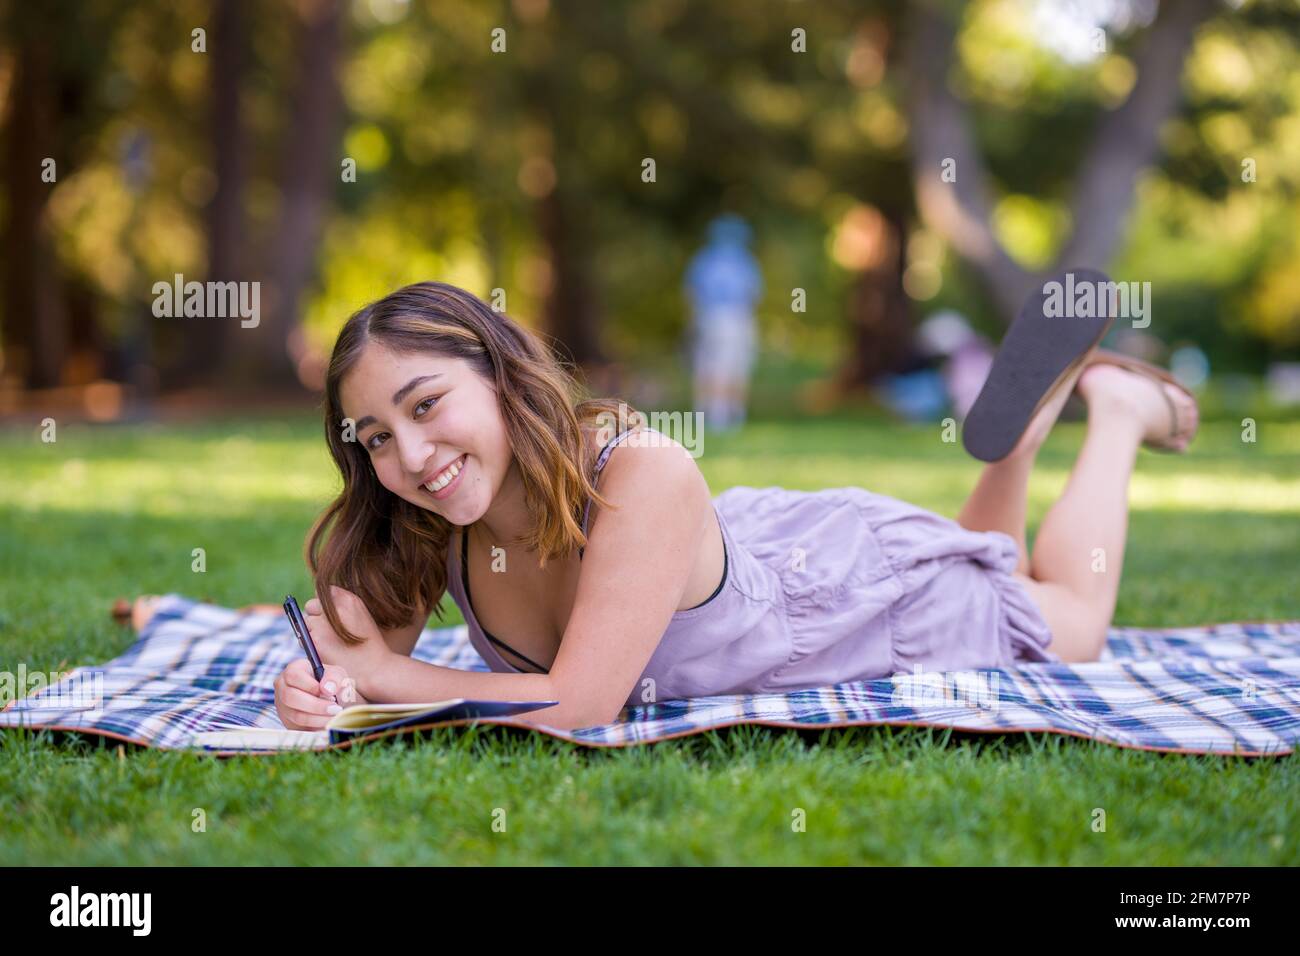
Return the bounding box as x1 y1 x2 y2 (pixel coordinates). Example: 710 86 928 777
8 0 1300 390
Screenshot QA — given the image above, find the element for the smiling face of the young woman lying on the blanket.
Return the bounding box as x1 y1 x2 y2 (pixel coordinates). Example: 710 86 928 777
339 342 514 525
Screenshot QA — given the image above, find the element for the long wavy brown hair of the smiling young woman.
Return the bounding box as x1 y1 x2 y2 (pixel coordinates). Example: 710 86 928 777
306 282 645 644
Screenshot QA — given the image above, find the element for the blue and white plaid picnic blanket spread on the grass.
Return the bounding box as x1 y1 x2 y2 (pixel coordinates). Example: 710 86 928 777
0 593 1300 756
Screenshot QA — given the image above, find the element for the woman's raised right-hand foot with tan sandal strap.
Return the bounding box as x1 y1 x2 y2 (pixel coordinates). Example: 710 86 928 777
1078 363 1200 451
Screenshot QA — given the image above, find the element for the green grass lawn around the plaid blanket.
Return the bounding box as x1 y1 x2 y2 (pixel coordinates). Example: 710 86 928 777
0 416 1300 865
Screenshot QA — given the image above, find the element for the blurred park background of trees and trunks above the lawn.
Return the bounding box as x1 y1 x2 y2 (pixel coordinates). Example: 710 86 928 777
0 0 1300 428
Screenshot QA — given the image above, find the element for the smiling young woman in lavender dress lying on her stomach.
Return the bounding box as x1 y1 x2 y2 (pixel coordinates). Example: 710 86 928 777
276 282 1197 728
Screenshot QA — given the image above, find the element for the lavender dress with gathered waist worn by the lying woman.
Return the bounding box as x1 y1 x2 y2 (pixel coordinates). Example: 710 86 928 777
447 432 1061 706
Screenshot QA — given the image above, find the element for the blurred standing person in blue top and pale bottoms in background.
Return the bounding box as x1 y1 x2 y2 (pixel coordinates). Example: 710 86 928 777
685 213 763 431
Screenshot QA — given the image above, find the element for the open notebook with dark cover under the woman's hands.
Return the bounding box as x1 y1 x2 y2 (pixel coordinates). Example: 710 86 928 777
190 697 559 750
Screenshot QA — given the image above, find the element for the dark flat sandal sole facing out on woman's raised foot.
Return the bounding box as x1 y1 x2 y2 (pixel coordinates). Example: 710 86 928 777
962 269 1115 462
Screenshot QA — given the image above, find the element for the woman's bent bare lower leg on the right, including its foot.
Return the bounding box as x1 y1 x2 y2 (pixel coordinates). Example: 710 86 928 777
1017 365 1196 662
